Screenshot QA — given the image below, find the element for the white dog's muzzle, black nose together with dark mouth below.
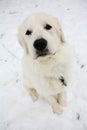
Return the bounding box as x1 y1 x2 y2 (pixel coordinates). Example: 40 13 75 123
33 38 49 57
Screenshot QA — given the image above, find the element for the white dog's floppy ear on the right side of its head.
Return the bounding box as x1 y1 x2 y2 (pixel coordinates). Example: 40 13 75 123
55 18 65 43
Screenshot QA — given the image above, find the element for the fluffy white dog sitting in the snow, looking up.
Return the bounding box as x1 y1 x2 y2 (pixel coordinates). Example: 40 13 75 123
18 13 73 114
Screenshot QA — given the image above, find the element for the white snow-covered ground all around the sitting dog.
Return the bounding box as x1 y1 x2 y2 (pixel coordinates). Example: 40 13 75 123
0 0 87 130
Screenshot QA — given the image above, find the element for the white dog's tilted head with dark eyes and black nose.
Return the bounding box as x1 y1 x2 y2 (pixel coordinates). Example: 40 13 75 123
18 13 65 59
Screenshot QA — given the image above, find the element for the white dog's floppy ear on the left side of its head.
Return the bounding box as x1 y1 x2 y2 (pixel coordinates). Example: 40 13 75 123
18 29 29 54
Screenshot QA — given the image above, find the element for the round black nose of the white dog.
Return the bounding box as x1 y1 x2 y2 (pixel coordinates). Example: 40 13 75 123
33 38 47 51
